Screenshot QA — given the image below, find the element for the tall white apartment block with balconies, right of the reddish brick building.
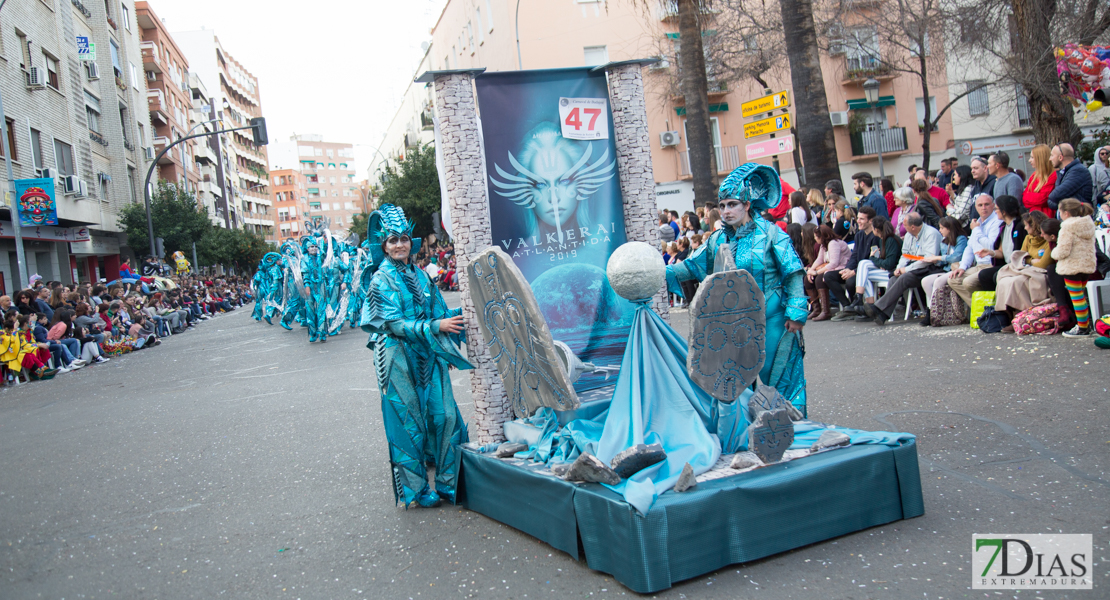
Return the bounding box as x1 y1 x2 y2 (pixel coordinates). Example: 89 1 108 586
173 29 275 240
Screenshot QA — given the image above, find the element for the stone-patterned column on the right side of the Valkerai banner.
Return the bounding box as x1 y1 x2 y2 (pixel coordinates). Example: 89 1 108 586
605 62 670 323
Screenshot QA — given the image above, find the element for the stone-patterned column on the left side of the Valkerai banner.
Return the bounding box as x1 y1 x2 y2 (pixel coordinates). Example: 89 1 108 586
434 73 513 445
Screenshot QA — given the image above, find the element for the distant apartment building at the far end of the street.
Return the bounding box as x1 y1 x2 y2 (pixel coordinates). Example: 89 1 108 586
290 134 363 235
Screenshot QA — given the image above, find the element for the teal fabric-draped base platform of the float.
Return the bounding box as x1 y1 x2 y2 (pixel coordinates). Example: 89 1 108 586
460 441 925 593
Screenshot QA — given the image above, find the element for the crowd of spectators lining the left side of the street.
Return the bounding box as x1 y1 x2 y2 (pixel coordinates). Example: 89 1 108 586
0 260 253 385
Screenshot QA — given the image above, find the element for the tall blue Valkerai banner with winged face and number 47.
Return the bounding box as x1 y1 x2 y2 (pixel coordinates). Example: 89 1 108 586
475 68 634 390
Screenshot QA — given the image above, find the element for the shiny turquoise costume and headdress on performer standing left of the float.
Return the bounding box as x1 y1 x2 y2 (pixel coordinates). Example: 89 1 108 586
361 204 473 507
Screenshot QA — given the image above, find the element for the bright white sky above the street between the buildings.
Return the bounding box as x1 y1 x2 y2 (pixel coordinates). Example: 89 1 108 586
150 0 446 180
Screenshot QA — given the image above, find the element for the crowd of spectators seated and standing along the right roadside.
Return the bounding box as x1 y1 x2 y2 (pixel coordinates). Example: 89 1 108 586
659 144 1110 337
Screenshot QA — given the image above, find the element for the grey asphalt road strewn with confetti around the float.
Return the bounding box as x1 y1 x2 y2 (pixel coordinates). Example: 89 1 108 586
0 298 1110 600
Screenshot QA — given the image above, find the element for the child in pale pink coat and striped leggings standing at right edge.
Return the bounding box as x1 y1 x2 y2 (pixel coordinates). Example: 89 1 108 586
1052 197 1098 337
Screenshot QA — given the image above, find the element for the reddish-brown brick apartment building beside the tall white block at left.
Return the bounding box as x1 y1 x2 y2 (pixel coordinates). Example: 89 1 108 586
135 1 200 194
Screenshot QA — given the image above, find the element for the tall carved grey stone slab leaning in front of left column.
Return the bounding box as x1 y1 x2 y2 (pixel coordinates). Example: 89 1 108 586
466 246 578 417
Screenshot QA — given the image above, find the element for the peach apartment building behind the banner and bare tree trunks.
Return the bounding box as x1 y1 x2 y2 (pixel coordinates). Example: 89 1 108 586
384 0 981 215
